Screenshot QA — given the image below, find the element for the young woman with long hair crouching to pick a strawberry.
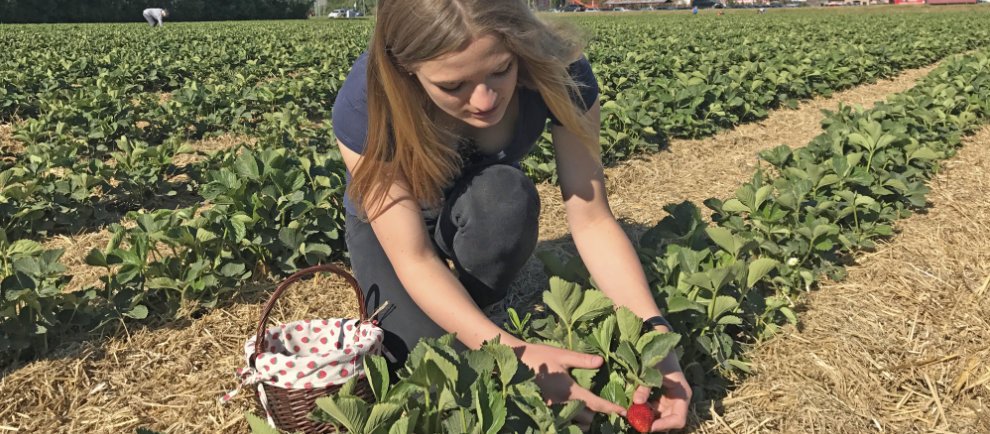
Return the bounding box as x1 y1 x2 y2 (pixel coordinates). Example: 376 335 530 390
333 0 691 431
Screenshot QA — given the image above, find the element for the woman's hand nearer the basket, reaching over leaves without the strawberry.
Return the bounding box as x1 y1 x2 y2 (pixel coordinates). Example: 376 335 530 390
516 344 626 431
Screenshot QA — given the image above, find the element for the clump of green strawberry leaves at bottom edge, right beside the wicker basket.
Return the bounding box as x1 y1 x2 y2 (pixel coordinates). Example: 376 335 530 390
313 335 583 434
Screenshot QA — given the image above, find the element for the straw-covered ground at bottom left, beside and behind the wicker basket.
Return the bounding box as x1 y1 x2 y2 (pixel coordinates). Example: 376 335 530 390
0 276 358 433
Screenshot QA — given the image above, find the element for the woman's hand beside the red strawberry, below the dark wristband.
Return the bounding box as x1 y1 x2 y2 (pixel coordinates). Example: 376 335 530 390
633 353 691 432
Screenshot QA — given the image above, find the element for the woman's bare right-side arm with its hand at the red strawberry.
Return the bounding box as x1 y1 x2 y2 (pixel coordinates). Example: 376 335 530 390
550 101 691 432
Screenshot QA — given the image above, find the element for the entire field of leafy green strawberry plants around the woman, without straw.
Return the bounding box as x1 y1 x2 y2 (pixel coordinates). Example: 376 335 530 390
0 9 990 433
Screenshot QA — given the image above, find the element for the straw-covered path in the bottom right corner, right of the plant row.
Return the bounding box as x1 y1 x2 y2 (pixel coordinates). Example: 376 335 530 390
700 126 990 433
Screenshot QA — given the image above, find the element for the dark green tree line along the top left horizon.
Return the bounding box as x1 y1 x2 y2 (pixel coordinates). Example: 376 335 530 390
0 0 312 23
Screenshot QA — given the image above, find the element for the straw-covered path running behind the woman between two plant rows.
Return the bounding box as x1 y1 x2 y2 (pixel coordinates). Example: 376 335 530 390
504 65 935 323
